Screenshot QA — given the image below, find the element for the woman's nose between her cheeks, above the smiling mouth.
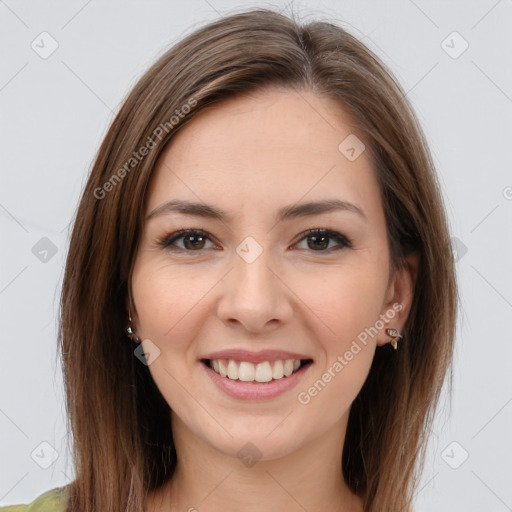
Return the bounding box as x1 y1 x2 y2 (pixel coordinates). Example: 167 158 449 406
217 245 293 333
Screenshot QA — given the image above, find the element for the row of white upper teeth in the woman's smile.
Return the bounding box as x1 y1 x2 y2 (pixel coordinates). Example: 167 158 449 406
210 359 300 382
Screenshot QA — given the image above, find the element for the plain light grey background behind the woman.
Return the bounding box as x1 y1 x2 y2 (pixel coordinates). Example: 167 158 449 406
0 0 512 512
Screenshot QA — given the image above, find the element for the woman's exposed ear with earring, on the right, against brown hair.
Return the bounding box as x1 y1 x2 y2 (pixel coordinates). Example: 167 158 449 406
377 253 420 346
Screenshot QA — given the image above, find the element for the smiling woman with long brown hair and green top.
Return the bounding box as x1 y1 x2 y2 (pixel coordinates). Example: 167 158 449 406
3 9 456 512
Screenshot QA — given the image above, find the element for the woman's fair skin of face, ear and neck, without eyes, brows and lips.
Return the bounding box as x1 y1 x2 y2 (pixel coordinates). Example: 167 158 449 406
131 89 417 512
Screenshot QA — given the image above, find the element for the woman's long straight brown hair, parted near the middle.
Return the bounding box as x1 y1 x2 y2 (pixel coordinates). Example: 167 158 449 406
59 9 457 512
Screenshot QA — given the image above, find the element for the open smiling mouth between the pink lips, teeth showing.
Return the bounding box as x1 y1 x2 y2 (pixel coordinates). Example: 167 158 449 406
201 359 313 384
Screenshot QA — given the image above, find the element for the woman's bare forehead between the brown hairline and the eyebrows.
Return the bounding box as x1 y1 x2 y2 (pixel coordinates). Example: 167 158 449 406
147 89 379 222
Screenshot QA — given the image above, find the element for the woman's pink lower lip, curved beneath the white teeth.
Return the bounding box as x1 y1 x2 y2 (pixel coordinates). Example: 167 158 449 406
200 362 312 400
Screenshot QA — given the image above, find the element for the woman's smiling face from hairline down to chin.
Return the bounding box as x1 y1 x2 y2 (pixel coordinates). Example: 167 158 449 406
132 89 410 460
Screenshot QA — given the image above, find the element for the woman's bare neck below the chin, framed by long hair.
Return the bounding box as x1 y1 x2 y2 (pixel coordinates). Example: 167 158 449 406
148 413 363 512
